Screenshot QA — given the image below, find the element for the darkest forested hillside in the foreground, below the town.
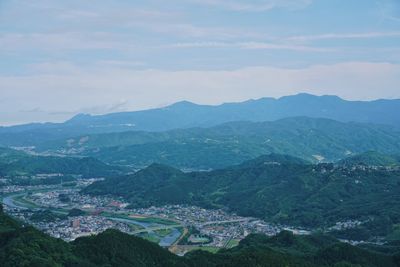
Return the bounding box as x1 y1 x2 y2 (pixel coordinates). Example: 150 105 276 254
0 205 400 267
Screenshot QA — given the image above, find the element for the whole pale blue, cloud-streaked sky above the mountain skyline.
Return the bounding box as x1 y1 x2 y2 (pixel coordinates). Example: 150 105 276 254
0 0 400 125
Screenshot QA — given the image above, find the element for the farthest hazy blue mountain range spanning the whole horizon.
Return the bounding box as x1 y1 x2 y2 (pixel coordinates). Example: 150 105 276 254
0 94 400 146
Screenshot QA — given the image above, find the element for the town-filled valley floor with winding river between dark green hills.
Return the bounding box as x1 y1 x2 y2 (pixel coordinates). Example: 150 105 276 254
0 180 310 255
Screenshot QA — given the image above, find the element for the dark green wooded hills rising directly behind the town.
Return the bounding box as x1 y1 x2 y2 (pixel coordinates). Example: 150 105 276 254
84 154 400 239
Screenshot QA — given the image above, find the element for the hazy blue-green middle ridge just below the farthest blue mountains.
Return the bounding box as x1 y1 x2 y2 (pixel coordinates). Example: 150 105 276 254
40 117 400 169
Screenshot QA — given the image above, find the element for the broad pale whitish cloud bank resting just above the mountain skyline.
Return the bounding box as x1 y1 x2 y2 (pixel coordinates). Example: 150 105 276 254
0 62 400 124
